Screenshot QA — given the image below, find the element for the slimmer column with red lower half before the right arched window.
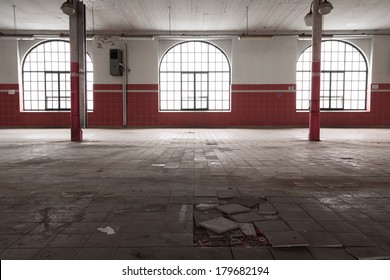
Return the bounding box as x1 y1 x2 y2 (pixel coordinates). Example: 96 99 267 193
309 0 322 141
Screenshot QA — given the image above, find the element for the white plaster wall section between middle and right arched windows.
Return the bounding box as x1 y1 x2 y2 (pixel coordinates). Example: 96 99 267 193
232 36 297 84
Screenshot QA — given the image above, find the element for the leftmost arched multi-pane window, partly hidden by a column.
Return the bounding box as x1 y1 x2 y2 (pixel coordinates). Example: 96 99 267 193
22 40 93 111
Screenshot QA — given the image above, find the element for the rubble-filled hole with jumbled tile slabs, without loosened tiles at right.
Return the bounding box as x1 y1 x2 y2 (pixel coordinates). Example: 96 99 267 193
194 195 272 247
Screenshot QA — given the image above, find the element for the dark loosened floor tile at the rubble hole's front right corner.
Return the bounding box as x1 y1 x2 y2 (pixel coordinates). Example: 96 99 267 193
264 231 309 247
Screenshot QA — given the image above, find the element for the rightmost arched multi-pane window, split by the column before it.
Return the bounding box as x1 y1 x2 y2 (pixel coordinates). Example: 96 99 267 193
296 40 368 110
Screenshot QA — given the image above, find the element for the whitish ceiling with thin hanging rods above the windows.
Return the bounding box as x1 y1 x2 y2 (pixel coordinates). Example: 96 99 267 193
0 0 390 35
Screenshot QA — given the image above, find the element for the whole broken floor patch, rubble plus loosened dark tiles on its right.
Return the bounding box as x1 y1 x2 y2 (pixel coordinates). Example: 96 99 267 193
193 195 318 248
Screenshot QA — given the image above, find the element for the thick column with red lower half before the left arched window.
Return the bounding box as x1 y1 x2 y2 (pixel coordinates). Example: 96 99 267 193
69 0 86 141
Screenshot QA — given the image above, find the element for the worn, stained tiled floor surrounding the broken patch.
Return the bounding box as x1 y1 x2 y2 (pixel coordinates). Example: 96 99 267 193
0 129 390 259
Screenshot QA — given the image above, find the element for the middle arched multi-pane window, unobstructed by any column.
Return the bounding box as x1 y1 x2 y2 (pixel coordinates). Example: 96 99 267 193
159 41 230 111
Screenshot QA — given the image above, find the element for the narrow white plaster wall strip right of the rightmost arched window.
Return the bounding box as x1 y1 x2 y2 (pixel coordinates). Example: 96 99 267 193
372 35 390 84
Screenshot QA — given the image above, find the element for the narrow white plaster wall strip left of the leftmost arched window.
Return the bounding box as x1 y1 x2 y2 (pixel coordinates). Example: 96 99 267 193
0 40 18 84
